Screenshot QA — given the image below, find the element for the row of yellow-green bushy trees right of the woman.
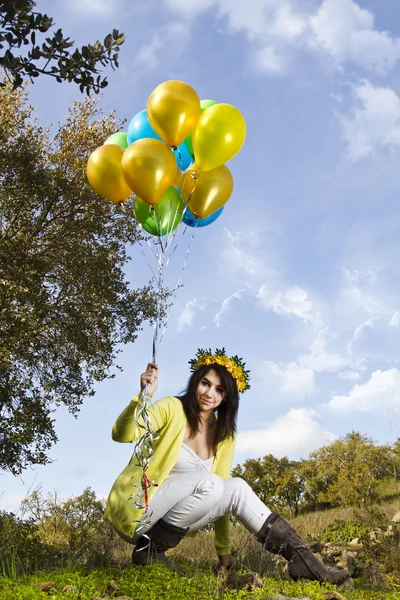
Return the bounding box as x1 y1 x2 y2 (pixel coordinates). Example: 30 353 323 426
232 431 400 516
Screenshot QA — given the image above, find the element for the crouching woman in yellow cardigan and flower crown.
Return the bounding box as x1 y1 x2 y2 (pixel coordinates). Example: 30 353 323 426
106 349 349 584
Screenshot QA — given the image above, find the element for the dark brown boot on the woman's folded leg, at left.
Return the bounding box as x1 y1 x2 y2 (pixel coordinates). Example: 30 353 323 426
132 519 189 573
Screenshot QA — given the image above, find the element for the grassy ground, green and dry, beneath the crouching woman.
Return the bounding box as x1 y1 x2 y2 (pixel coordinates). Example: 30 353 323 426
0 482 400 600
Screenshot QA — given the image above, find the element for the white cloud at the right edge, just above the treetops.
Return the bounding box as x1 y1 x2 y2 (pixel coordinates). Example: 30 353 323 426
329 369 400 414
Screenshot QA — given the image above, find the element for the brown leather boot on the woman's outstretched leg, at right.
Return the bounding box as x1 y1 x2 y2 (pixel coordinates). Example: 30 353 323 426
257 512 350 585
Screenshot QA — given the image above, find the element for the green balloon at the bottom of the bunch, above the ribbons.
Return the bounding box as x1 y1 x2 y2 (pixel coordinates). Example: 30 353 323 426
135 187 185 236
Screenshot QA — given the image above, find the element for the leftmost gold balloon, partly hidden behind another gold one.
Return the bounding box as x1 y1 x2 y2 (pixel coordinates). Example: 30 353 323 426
86 144 132 204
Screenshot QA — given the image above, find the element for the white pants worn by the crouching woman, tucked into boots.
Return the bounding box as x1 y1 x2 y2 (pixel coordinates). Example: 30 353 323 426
132 471 271 543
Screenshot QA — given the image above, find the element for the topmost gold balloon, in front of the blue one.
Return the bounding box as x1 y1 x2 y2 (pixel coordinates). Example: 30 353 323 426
146 80 200 147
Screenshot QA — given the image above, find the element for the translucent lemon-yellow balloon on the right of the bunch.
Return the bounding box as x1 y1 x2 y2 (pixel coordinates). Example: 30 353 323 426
193 104 246 171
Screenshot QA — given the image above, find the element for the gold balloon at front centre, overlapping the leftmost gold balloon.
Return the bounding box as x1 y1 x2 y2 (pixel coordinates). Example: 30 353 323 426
122 138 177 204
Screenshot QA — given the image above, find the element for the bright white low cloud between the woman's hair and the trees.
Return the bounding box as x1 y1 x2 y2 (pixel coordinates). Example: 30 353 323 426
236 408 335 459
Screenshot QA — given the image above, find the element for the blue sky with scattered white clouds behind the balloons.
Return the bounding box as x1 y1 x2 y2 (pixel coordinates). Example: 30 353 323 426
0 0 400 510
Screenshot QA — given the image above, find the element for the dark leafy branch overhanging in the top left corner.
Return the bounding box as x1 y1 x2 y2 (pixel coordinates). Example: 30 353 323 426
0 0 125 93
